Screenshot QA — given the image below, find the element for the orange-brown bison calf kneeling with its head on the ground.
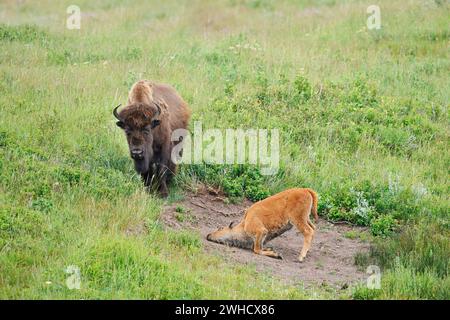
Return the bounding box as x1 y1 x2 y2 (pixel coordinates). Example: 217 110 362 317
207 188 319 261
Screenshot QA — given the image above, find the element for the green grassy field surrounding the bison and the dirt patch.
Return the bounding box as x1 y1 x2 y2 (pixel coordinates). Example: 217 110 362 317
0 0 450 299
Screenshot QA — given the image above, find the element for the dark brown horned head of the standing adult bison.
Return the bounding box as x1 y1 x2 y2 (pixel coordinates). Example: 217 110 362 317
113 102 161 174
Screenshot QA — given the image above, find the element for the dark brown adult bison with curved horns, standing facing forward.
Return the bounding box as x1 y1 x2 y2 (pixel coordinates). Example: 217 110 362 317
113 80 190 197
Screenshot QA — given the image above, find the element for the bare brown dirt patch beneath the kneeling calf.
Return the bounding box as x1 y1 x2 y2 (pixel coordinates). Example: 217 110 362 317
161 190 369 288
